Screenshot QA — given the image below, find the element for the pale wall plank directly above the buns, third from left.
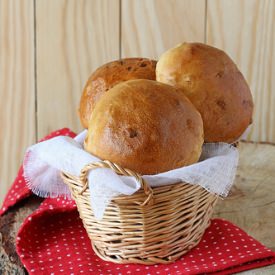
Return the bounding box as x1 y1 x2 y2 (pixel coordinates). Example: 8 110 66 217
121 0 205 59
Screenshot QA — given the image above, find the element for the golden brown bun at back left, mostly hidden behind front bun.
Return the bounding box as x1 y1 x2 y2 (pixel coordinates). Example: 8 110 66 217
79 58 157 128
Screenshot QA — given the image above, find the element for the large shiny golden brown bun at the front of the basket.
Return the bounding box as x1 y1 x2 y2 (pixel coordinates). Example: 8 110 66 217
84 80 203 174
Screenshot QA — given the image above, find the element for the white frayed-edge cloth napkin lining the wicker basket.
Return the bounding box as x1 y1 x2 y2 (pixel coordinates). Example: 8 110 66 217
23 130 239 219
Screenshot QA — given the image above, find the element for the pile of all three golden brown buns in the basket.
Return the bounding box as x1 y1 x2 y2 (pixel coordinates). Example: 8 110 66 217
79 43 253 175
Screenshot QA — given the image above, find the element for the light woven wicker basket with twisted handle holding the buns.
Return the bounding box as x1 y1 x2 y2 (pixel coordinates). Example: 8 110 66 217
62 161 217 265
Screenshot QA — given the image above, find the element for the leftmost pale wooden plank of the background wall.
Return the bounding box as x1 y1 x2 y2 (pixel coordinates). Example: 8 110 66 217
0 0 35 207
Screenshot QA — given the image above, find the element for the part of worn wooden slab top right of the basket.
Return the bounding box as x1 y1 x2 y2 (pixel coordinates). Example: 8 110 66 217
215 142 275 251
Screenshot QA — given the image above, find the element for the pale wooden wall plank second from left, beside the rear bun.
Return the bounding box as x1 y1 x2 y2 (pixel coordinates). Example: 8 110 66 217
36 0 119 138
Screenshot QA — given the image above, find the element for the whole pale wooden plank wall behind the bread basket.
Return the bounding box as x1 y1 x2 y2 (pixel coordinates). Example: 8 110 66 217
0 0 275 203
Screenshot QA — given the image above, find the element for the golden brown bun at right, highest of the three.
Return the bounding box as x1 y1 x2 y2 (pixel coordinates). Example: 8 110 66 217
156 43 253 143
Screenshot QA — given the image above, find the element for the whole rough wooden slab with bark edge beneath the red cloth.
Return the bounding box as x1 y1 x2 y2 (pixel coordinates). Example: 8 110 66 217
0 142 275 275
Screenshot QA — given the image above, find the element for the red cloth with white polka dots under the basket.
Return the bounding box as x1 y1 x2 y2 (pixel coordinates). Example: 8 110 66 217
0 129 275 275
